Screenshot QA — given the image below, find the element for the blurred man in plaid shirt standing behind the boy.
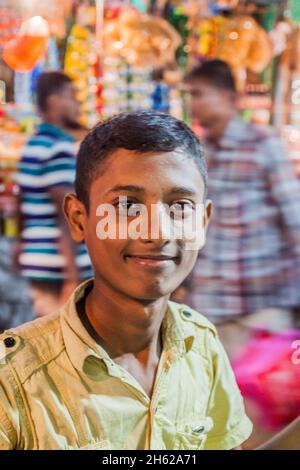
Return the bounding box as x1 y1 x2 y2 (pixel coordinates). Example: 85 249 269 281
187 60 300 354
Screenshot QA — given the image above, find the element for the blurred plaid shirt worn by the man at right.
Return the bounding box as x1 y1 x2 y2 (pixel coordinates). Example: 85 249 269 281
187 117 300 322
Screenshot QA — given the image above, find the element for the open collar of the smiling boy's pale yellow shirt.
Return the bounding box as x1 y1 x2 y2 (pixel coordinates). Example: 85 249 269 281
60 279 195 372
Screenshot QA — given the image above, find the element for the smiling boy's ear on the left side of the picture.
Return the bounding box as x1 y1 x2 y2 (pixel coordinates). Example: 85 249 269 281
63 193 87 243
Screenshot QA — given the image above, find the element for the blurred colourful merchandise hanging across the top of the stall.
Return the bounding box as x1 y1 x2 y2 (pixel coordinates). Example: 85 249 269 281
0 0 298 128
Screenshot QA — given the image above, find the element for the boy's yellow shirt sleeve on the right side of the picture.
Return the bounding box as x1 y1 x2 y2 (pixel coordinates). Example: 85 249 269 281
205 333 252 450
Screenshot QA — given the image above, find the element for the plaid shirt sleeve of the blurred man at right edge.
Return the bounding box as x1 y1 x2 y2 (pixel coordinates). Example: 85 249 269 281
263 135 300 258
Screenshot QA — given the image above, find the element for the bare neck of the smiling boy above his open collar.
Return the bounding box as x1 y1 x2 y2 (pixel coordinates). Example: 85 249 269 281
86 279 169 368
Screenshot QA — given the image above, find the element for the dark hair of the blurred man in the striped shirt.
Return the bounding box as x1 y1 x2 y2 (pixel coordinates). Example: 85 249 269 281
36 71 72 112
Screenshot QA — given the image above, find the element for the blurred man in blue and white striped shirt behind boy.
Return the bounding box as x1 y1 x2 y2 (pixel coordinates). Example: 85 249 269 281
18 71 92 316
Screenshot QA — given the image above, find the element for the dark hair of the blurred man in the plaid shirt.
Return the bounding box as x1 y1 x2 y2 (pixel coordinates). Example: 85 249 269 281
186 59 236 92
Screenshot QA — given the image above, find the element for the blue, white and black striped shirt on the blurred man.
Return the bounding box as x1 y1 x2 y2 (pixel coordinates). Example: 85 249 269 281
17 123 92 281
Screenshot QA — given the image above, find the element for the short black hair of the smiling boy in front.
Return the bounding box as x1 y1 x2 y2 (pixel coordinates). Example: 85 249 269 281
75 111 207 210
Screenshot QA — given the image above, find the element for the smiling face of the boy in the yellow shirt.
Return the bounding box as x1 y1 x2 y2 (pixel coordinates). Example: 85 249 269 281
65 149 211 300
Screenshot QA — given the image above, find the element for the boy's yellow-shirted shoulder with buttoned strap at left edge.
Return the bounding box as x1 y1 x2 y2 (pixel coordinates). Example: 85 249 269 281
0 311 64 383
